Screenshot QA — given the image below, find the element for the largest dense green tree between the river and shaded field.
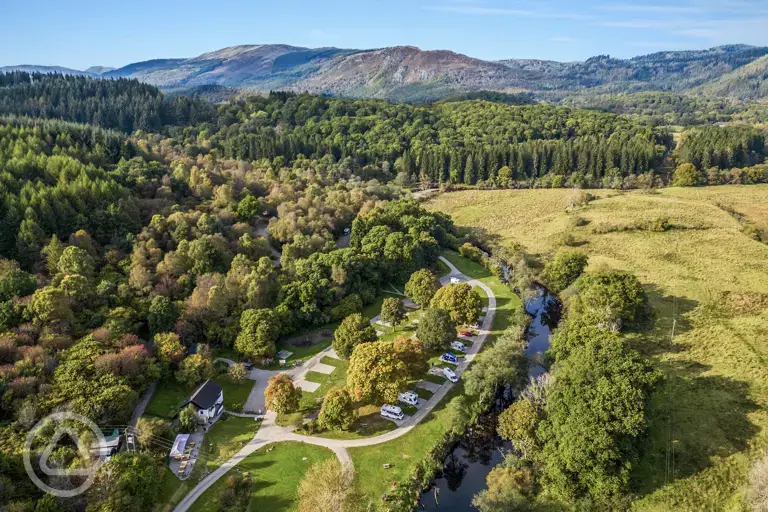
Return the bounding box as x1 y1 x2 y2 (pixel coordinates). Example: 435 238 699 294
537 338 658 508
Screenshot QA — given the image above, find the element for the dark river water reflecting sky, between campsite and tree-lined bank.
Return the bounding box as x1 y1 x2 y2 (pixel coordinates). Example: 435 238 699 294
420 287 560 512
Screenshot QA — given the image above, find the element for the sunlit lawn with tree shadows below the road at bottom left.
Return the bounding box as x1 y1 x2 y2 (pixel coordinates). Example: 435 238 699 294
190 442 333 512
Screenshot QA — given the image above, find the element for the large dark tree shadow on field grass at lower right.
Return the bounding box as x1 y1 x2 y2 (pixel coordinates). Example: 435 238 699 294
632 361 759 494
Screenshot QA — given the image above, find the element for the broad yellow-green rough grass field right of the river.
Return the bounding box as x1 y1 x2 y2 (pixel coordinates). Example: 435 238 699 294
427 185 768 511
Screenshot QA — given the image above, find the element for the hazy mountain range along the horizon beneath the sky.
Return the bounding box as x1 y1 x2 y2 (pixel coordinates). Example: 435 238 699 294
6 44 768 101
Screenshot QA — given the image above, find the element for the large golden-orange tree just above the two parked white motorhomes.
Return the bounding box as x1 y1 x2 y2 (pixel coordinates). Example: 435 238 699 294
346 341 410 404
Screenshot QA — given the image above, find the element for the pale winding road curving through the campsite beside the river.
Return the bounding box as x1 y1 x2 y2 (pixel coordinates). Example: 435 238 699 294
174 256 496 512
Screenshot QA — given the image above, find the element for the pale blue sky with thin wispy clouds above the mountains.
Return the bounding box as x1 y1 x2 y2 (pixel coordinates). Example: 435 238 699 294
0 0 768 69
